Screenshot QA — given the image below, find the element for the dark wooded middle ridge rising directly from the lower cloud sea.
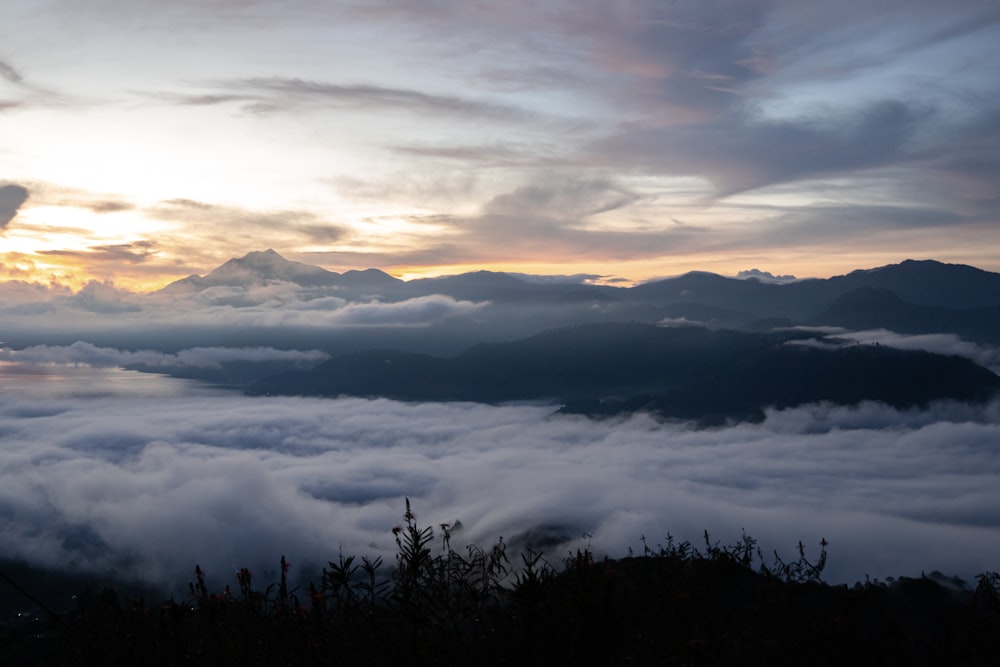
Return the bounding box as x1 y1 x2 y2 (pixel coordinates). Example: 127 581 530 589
250 323 1000 425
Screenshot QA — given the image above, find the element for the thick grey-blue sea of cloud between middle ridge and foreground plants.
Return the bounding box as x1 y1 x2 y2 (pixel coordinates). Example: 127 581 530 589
0 388 1000 585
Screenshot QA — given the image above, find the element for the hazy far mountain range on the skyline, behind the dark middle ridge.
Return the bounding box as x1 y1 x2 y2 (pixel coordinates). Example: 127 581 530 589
161 250 1000 344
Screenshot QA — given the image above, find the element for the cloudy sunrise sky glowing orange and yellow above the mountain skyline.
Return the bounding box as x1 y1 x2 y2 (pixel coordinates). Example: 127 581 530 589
0 0 1000 291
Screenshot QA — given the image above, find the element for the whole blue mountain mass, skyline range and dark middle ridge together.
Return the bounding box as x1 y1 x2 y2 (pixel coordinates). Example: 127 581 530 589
146 250 1000 425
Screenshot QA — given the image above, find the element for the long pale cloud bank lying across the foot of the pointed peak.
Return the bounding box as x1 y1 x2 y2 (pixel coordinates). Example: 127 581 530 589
0 281 489 350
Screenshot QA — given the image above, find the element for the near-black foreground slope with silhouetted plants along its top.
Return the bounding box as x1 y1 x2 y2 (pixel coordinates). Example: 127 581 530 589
0 503 1000 666
